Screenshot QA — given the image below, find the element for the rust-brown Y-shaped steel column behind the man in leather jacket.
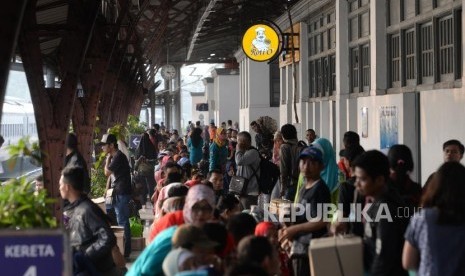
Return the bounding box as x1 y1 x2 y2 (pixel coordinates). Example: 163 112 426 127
18 0 100 220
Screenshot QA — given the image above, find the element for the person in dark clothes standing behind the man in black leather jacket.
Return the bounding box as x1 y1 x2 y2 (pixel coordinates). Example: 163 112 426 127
64 133 90 194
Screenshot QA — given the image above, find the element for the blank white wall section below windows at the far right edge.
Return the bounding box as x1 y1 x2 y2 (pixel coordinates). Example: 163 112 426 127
420 89 465 184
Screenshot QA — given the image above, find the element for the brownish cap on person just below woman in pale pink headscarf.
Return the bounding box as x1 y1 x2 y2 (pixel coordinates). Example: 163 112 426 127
172 224 218 249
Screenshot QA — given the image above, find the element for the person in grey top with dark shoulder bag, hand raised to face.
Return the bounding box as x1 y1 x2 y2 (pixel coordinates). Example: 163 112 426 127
235 131 260 209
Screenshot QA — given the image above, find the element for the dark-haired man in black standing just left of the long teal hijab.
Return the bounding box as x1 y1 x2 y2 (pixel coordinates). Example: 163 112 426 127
279 124 305 201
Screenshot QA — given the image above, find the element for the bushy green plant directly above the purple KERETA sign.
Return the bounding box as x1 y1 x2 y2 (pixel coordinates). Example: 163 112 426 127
0 177 57 229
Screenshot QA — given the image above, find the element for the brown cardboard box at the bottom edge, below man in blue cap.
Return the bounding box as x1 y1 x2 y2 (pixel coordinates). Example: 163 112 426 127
309 236 363 276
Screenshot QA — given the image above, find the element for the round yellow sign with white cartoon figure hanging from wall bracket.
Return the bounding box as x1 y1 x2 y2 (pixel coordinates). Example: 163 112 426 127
242 24 279 61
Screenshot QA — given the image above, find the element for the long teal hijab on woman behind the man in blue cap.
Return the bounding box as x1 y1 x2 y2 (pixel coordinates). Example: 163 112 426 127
312 138 339 193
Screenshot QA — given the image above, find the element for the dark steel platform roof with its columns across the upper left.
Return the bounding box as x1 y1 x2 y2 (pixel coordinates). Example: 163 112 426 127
0 0 289 220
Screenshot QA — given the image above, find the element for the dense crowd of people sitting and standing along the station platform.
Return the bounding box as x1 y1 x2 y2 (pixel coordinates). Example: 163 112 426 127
54 121 465 275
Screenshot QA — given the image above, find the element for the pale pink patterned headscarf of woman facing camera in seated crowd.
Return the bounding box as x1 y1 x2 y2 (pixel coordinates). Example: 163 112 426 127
182 184 215 223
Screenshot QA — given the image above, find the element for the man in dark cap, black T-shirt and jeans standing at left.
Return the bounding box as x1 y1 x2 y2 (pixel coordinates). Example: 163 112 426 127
99 134 131 258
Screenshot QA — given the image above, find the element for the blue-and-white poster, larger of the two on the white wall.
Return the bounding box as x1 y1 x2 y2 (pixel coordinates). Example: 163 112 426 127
379 106 399 149
